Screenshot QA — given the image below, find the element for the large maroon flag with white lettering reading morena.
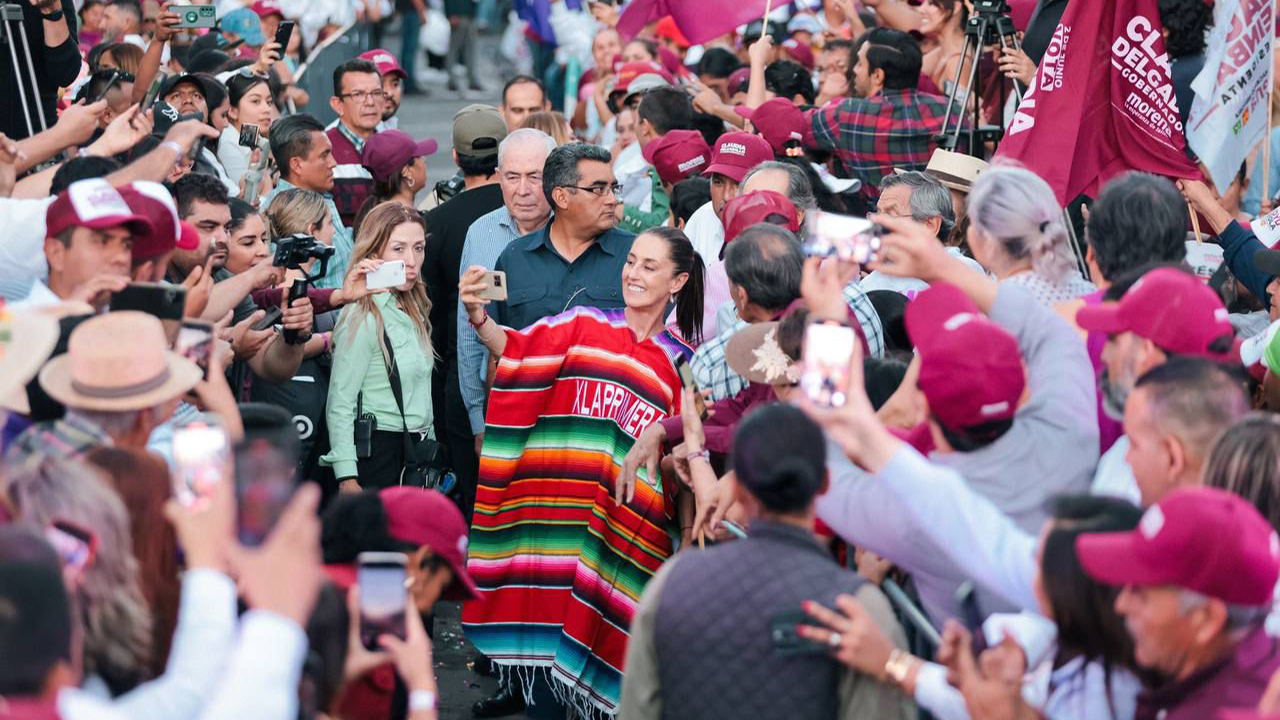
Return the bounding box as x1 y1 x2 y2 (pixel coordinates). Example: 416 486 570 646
996 0 1199 204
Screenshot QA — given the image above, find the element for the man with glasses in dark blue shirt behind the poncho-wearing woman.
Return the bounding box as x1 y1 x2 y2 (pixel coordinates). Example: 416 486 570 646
493 142 635 329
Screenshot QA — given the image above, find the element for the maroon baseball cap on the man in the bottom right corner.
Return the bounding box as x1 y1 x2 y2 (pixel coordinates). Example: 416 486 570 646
1075 487 1280 607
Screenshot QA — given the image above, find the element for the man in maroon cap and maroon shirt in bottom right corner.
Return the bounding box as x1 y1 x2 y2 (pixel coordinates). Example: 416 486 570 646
1076 487 1280 720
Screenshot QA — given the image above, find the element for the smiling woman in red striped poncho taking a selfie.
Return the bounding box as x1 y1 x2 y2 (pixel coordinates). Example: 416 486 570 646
458 228 703 715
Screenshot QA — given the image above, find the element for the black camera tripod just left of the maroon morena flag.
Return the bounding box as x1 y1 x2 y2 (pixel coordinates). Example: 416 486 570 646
934 0 1023 158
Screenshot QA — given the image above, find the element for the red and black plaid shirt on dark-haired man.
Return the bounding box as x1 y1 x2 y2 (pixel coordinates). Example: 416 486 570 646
805 90 956 199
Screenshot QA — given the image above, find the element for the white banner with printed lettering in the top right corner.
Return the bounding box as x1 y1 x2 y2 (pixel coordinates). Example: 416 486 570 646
1187 0 1280 193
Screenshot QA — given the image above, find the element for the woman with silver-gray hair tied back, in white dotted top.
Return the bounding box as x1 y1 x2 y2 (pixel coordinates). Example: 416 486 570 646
968 167 1097 305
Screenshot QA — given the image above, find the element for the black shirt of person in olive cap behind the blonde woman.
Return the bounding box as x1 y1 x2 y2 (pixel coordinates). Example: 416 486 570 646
422 183 502 365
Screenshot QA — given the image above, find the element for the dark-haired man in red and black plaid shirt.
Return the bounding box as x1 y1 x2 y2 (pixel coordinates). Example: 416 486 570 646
805 28 947 200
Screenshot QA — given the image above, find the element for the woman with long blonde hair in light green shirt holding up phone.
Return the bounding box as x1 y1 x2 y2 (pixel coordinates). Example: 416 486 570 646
320 202 435 492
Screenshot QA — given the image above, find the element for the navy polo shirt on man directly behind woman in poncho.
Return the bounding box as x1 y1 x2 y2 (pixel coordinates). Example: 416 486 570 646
492 219 636 329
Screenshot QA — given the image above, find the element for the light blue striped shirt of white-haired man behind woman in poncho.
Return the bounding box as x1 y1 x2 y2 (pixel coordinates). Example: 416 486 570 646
457 205 521 434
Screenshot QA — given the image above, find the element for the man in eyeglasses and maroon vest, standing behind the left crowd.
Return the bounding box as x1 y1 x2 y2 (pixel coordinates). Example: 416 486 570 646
325 58 387 228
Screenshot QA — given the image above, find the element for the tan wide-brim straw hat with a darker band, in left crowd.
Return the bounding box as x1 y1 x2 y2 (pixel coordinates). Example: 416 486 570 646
40 311 204 413
